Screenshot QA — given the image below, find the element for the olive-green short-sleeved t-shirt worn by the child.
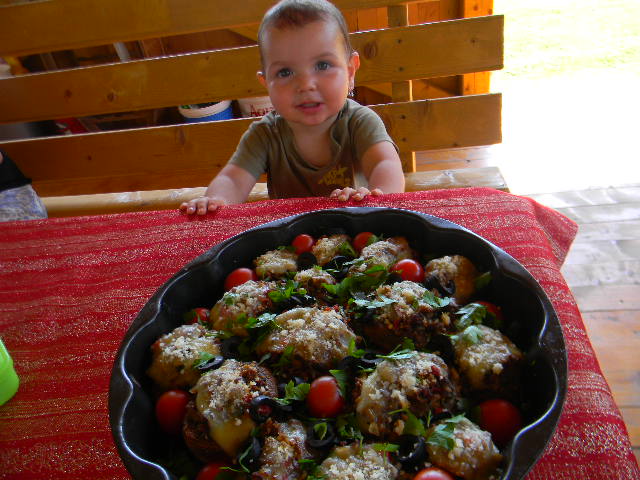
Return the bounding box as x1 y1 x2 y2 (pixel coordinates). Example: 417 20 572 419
229 99 397 198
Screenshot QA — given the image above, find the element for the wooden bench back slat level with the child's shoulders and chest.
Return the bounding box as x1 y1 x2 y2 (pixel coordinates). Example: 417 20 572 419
0 94 501 196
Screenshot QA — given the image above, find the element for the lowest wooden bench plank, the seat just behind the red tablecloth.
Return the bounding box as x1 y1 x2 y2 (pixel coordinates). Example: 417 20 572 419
42 167 508 217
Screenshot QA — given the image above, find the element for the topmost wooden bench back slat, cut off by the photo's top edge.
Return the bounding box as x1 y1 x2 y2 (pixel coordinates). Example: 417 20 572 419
0 0 420 56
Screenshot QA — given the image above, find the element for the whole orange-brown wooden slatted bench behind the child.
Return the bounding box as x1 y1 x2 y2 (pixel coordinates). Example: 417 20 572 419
0 0 506 216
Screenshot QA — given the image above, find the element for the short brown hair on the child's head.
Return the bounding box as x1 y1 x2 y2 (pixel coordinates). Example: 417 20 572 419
258 0 353 65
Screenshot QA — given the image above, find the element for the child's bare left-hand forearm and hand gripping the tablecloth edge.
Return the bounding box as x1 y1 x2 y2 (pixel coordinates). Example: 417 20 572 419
180 164 256 215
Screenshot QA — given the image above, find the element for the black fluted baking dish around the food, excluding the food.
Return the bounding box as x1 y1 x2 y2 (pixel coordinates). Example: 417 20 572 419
109 208 567 480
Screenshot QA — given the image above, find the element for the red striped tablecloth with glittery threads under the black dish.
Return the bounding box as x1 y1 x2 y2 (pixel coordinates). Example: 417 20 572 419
0 189 640 480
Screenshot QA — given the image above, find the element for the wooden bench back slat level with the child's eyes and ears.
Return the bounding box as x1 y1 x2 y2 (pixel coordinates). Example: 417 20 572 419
0 15 504 123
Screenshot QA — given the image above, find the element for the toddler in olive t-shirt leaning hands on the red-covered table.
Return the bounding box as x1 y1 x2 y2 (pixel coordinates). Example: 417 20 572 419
180 0 404 215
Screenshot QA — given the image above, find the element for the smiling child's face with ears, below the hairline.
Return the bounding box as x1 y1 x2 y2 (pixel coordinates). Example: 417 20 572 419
259 21 360 128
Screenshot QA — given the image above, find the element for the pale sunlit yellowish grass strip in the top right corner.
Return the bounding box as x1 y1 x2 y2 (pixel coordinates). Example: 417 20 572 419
494 0 640 78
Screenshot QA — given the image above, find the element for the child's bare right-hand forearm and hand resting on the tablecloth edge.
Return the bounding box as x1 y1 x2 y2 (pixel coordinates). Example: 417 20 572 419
330 142 404 201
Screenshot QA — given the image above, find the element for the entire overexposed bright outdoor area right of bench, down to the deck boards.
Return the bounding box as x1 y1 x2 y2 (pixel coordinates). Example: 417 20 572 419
484 0 640 195
